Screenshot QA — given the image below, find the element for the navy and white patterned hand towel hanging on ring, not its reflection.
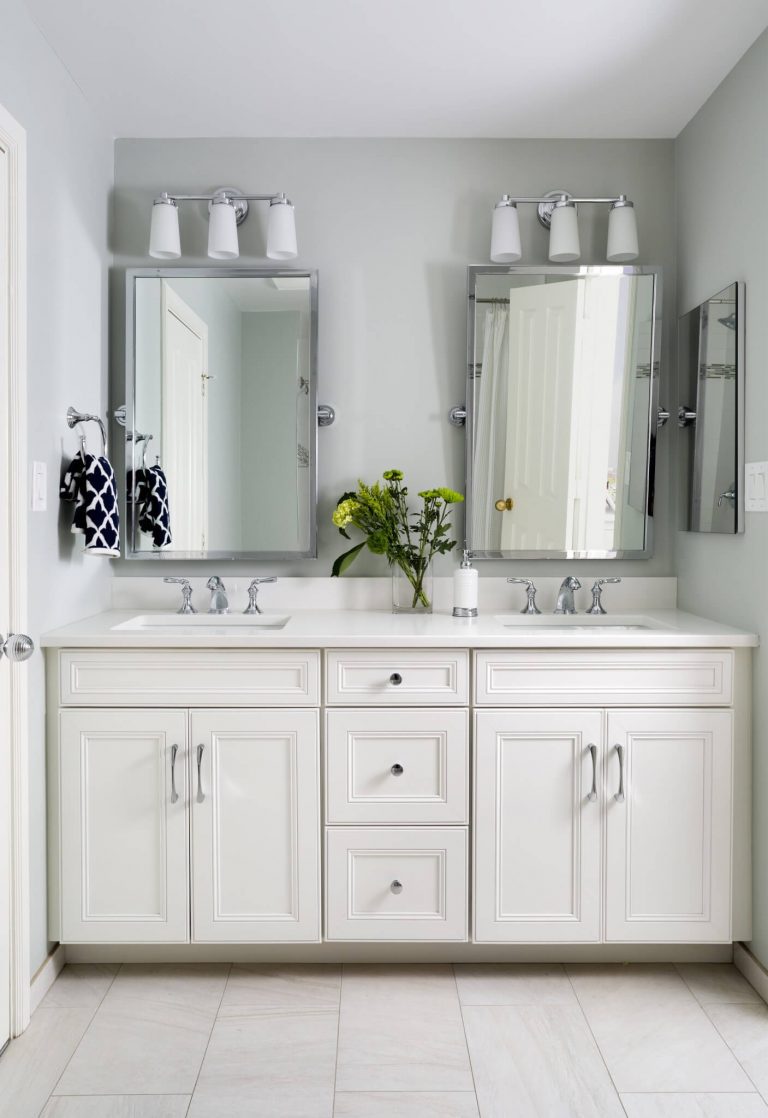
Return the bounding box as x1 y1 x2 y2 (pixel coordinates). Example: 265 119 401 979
59 453 120 558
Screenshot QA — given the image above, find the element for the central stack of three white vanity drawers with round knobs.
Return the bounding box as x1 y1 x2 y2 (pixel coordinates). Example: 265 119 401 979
325 650 470 941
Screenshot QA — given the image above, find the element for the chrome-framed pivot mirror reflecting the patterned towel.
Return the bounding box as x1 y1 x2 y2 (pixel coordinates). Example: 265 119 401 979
125 268 317 560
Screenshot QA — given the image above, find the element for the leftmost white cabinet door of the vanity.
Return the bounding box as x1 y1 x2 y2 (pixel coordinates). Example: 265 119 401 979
59 710 189 944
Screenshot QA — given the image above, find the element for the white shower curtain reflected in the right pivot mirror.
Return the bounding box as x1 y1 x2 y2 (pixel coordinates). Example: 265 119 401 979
471 306 509 551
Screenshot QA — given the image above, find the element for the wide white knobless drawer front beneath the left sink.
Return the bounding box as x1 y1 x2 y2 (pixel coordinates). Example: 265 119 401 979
59 648 320 707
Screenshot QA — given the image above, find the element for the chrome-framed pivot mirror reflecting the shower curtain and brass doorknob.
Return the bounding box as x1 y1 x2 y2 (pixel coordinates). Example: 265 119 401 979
466 266 661 559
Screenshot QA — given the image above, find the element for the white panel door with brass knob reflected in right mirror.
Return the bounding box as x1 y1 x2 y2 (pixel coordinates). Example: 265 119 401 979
499 280 580 551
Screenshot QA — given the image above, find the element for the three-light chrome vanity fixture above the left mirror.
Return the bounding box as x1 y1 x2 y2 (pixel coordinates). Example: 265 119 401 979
150 187 298 260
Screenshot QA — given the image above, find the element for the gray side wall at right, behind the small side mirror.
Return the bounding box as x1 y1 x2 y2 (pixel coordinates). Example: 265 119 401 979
675 32 768 965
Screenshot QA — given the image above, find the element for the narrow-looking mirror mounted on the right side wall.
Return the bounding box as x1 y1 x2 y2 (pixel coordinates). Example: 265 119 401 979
677 283 745 533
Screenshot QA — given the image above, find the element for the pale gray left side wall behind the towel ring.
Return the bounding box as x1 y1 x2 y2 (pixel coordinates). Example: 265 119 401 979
0 2 113 973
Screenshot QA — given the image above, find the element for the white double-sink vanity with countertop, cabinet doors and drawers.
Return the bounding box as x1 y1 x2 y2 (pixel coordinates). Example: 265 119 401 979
44 609 757 957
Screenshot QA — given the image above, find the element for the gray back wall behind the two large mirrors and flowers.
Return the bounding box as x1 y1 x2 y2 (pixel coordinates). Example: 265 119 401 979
113 140 674 576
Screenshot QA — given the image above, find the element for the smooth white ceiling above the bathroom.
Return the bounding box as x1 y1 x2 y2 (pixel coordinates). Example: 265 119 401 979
27 0 768 138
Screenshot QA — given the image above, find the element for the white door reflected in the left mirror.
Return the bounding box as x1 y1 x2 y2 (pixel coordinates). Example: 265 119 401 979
161 282 208 551
